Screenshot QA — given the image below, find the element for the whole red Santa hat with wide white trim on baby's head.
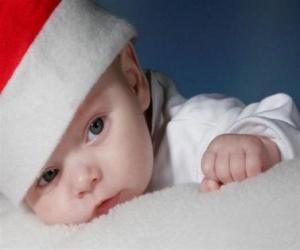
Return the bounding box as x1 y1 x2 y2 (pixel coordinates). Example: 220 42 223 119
0 0 135 205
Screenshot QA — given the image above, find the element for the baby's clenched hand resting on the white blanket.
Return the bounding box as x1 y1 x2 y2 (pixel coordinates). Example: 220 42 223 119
200 134 281 192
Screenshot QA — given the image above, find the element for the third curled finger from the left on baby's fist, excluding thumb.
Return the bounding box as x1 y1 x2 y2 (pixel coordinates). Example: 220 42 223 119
230 150 247 181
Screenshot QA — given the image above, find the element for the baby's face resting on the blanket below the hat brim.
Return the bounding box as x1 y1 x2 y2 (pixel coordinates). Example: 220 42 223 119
25 47 153 224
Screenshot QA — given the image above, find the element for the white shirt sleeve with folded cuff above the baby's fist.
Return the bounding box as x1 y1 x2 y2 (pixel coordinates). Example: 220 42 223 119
224 94 300 160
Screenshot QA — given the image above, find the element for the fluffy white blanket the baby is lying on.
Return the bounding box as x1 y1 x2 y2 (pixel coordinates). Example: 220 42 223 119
0 160 300 250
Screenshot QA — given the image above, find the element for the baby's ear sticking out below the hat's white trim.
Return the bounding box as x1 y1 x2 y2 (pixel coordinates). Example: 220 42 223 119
120 42 150 111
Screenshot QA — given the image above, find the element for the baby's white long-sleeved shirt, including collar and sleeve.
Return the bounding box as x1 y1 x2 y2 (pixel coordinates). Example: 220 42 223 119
147 71 300 191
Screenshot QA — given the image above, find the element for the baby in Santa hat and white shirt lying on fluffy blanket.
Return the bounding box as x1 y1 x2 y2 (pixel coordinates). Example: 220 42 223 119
0 0 300 224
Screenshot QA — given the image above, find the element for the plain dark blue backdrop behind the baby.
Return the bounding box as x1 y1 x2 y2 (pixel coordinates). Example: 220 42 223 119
98 0 300 106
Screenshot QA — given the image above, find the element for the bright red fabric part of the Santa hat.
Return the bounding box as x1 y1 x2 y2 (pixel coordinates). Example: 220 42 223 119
0 0 61 93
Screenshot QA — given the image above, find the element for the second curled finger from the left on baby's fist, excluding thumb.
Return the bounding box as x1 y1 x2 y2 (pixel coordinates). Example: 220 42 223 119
215 153 233 184
